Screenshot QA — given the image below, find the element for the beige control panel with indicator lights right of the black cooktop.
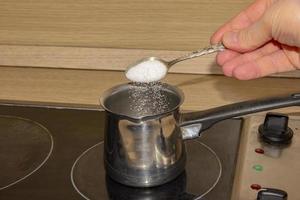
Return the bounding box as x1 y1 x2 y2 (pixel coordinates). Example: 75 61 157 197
232 113 300 200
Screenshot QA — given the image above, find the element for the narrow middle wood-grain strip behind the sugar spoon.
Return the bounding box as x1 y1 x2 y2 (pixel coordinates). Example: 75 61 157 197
0 45 300 77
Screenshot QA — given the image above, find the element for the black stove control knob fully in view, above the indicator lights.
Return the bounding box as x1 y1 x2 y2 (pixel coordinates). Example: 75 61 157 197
258 113 293 145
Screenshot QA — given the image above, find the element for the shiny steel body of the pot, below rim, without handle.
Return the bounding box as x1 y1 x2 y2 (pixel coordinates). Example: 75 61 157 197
104 109 186 187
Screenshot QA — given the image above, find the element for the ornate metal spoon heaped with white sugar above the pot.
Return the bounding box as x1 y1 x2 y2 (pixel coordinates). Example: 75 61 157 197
125 44 225 82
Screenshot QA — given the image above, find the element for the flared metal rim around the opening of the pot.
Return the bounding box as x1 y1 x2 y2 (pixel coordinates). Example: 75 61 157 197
99 82 185 121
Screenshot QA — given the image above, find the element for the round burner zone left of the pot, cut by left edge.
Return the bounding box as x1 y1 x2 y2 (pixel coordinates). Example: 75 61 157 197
0 115 54 191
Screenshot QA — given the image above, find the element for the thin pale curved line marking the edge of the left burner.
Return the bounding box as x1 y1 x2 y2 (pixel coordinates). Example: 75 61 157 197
0 115 54 191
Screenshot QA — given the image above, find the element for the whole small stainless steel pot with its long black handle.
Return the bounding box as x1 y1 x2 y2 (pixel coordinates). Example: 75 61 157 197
101 84 300 187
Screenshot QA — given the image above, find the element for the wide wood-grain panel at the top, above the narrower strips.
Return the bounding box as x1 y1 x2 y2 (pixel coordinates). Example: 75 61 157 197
0 0 252 50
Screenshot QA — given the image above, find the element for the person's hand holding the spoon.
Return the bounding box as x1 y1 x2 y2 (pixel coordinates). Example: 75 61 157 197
211 0 300 80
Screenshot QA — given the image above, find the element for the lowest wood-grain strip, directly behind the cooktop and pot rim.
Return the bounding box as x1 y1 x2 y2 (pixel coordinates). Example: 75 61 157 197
0 67 300 110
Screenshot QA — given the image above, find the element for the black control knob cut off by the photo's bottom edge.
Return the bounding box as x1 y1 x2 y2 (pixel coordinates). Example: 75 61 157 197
257 188 288 200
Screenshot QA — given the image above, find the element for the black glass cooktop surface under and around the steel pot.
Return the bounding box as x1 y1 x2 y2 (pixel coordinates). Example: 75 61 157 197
0 102 242 200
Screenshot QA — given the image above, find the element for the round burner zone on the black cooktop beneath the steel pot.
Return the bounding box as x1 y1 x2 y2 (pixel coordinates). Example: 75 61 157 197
71 141 222 200
